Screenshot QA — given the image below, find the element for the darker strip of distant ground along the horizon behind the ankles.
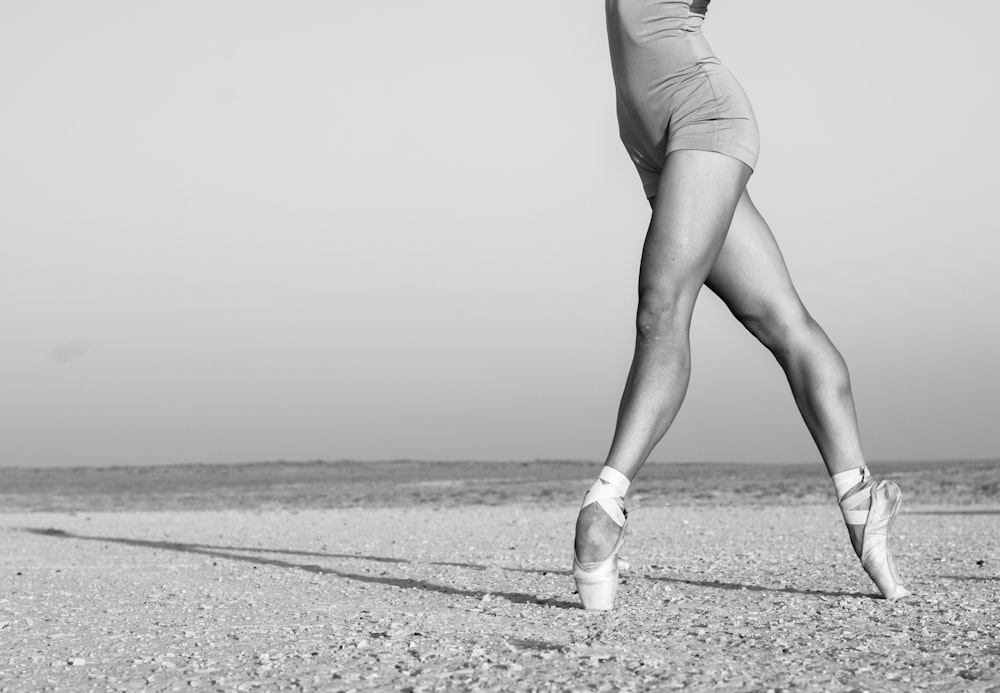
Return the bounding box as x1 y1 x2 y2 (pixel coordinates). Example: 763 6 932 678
0 460 1000 512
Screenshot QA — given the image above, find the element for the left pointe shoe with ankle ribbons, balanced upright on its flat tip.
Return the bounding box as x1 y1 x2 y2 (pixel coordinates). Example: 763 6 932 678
573 467 628 611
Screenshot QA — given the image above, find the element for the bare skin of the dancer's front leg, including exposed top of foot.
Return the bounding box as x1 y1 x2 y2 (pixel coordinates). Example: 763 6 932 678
576 150 750 562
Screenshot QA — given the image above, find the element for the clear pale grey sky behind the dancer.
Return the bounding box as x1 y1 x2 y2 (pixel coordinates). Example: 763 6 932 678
0 0 1000 467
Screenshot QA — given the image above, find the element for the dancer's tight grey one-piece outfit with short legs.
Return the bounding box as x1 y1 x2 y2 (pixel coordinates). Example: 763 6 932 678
605 0 760 197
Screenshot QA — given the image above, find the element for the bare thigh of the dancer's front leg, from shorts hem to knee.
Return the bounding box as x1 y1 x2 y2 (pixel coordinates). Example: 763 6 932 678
639 150 750 305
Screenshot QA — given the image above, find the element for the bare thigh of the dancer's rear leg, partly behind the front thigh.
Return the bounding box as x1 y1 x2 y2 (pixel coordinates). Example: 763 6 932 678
705 190 805 332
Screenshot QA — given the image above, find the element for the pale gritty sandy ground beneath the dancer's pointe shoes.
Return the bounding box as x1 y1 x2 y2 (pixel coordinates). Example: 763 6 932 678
0 502 1000 691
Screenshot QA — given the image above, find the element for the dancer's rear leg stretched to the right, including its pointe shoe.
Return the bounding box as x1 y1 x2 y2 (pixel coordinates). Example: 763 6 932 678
706 191 906 599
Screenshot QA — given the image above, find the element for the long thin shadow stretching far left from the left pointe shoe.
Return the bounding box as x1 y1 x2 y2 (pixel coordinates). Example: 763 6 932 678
22 527 582 609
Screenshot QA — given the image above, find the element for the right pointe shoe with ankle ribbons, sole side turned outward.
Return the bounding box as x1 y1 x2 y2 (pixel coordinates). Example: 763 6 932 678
840 469 909 602
